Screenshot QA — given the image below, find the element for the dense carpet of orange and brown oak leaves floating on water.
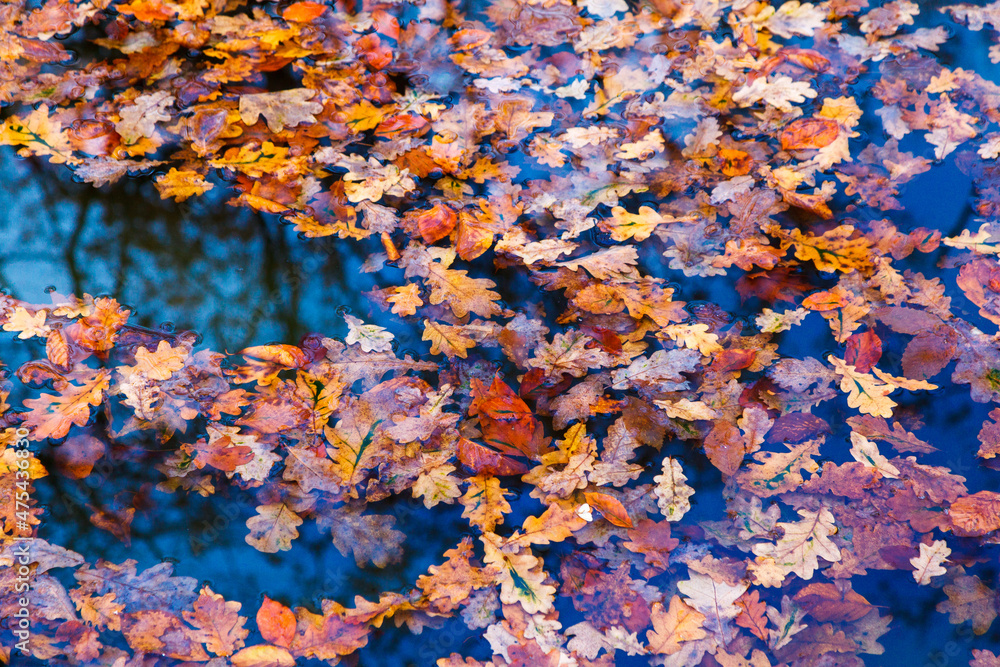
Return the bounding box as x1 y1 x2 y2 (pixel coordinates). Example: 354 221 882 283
7 0 1000 667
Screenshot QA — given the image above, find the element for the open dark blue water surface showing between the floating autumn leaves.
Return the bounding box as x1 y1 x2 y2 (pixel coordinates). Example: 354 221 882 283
0 3 1000 667
